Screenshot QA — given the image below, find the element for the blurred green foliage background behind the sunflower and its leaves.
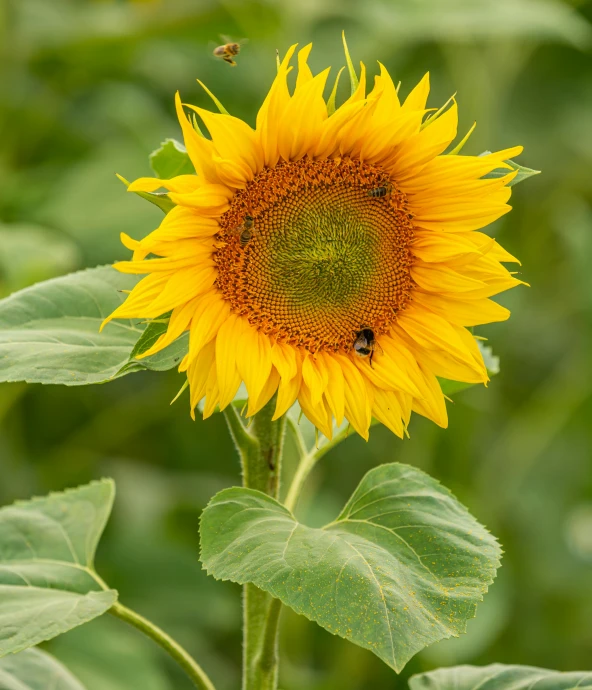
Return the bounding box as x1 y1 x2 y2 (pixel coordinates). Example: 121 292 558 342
0 0 592 690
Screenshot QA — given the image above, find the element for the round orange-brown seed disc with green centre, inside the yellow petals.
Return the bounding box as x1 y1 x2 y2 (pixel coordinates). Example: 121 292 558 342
215 158 413 352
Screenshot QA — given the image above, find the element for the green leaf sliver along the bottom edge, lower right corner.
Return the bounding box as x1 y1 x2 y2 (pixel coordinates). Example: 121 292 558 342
409 664 592 690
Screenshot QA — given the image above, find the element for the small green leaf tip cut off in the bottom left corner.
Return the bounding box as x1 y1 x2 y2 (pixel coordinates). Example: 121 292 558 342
0 649 84 690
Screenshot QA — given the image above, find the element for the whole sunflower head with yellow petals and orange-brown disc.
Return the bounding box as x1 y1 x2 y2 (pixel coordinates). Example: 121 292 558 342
104 39 522 439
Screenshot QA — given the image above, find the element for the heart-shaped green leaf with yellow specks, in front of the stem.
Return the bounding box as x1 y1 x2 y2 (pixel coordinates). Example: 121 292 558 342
201 463 500 671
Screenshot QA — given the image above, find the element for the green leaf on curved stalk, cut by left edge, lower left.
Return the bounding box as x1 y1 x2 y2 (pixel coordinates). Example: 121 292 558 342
0 480 117 656
